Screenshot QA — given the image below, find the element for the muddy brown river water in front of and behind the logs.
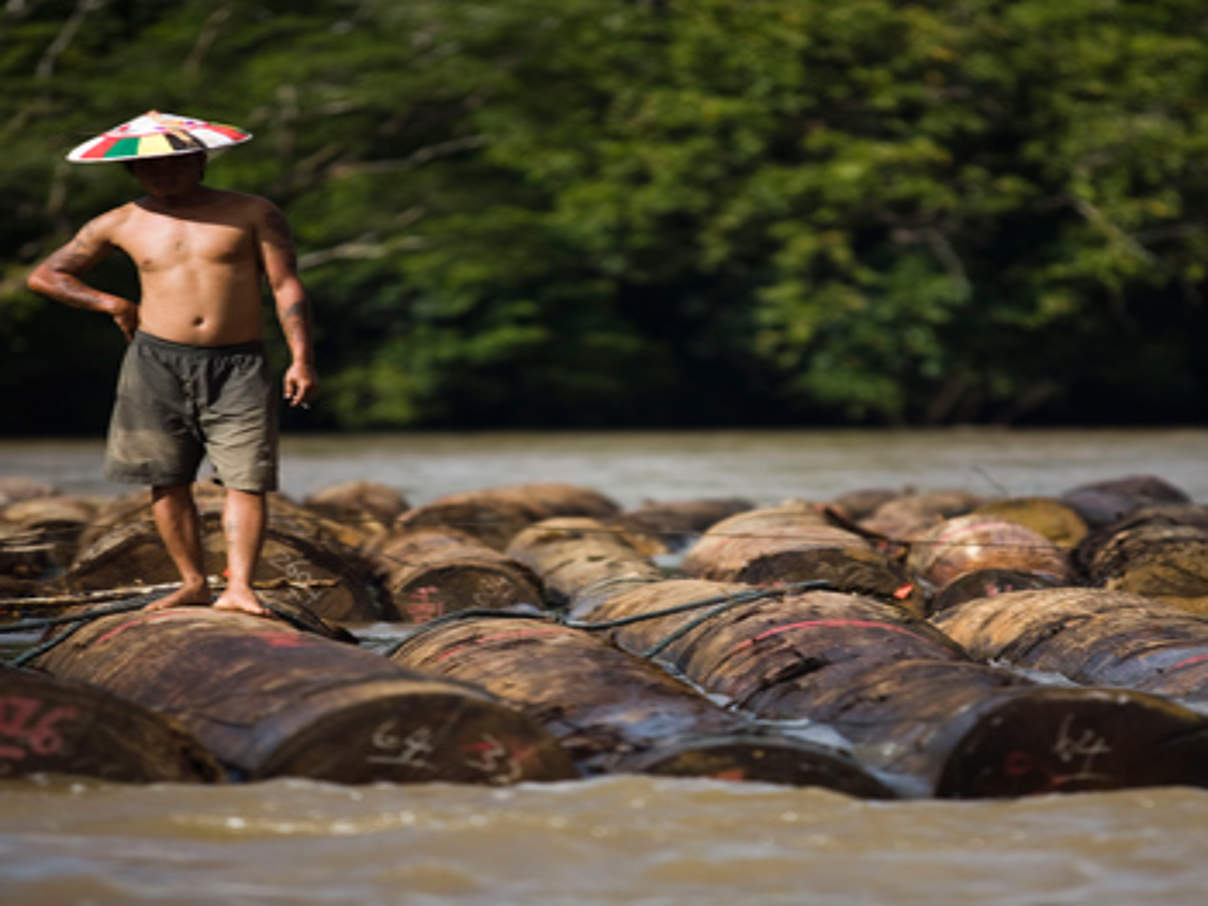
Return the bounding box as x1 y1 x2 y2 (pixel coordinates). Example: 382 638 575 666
0 430 1208 906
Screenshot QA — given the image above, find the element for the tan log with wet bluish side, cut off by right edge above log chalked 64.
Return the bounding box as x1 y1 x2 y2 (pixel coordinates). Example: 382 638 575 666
931 588 1208 701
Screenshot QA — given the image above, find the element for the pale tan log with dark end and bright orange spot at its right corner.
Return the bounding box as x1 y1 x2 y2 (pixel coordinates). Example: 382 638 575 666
681 501 923 614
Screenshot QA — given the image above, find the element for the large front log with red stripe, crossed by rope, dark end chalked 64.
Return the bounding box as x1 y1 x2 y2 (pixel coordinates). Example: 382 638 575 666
586 581 1208 796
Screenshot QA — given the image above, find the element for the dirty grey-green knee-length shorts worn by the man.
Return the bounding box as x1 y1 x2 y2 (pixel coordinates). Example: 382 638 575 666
105 331 277 492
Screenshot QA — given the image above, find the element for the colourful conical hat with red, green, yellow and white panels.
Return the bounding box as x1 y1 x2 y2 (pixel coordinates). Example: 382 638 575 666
68 110 251 163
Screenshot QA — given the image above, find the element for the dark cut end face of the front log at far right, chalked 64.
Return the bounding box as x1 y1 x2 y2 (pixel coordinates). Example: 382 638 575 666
935 687 1208 798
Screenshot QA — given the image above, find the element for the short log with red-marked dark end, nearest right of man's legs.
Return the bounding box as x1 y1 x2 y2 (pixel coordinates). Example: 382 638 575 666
371 529 542 623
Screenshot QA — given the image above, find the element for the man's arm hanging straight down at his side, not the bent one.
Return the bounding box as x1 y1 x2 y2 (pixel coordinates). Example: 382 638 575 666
256 202 319 406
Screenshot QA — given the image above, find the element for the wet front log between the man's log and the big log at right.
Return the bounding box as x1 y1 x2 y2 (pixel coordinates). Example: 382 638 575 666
391 617 892 797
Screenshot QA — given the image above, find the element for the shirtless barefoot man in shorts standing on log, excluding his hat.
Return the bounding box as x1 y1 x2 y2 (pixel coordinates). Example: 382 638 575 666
28 151 318 615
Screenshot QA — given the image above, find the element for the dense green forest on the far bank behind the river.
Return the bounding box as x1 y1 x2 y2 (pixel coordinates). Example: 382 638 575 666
0 0 1208 435
